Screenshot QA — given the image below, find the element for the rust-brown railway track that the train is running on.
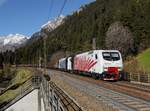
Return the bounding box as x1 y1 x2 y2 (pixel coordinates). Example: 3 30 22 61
57 70 150 102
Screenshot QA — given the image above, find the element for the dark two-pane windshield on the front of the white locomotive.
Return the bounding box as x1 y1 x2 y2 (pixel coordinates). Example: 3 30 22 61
102 52 120 61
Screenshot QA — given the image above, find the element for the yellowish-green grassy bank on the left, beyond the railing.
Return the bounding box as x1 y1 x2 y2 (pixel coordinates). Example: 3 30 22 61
0 68 34 103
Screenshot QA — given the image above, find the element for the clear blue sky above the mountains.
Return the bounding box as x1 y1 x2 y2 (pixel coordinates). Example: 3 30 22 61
0 0 93 36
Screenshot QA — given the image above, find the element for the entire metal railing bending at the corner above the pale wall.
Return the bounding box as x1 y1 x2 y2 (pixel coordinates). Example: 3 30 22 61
0 75 82 111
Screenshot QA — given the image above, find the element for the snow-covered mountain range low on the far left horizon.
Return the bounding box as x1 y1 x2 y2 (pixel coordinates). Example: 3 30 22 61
0 34 28 52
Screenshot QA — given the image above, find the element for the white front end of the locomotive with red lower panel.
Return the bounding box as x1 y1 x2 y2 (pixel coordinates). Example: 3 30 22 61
102 50 123 80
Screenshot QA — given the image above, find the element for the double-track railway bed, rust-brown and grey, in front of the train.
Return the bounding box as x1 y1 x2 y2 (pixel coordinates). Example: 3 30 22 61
49 72 150 111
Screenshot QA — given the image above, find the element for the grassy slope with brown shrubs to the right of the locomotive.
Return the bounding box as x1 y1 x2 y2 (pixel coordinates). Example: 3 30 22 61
124 48 150 74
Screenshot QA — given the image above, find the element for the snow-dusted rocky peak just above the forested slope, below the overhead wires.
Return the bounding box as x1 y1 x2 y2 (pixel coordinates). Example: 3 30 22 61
41 15 65 31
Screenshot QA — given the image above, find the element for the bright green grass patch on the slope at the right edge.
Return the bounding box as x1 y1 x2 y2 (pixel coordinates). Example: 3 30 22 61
137 48 150 72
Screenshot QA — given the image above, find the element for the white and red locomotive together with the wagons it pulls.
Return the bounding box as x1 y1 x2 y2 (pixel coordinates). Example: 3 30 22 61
57 50 123 81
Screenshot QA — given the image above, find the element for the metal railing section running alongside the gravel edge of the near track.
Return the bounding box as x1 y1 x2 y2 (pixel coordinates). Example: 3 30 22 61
39 78 82 111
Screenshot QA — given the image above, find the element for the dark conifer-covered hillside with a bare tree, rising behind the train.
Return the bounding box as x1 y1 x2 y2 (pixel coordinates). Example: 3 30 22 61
5 0 150 63
